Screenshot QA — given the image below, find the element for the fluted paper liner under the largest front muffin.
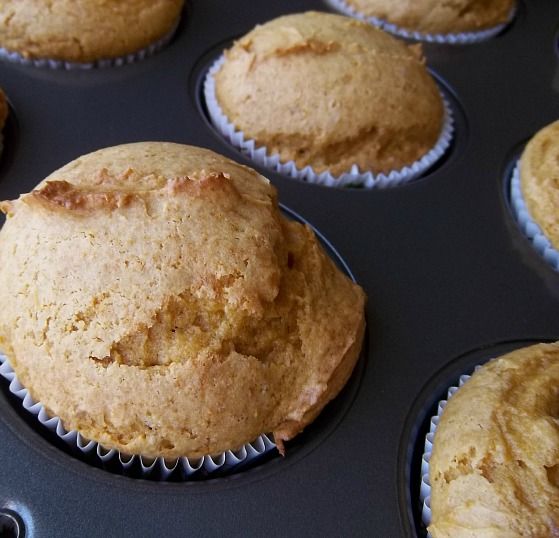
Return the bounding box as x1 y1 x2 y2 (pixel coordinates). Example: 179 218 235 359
0 353 276 480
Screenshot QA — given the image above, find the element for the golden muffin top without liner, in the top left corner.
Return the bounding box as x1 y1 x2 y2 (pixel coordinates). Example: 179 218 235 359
0 0 183 63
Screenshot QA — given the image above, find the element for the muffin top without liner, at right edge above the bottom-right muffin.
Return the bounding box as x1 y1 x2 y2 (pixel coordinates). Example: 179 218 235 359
520 121 559 249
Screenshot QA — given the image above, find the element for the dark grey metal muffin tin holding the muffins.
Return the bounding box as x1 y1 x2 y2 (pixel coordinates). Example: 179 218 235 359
0 0 559 537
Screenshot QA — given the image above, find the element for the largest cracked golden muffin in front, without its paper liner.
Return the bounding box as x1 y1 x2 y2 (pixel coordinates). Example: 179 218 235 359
0 142 364 458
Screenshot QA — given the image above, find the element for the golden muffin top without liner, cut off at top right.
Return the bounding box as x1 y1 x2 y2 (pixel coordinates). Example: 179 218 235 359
345 0 514 34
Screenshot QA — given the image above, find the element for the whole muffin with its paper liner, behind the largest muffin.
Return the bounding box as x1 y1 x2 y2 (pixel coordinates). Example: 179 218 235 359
204 12 453 187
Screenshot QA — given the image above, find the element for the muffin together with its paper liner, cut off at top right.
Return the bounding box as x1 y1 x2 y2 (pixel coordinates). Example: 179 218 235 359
327 0 516 45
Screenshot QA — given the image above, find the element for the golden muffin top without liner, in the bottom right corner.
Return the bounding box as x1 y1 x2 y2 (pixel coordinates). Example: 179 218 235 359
428 343 559 538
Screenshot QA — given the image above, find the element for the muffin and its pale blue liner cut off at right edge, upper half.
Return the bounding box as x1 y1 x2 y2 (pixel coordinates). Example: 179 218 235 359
510 121 559 271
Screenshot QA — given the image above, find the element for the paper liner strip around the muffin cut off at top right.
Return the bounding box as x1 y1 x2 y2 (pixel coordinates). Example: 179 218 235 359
325 0 516 45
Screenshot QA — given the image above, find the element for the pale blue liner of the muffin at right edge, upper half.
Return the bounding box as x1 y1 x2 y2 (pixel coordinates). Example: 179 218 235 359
510 161 559 271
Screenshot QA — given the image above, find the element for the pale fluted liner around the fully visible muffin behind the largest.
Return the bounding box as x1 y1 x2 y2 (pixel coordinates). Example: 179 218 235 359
204 55 454 188
